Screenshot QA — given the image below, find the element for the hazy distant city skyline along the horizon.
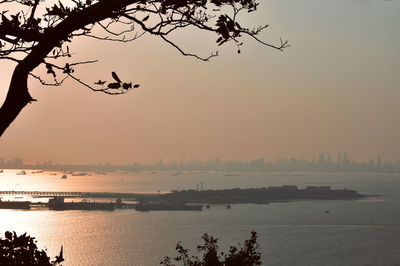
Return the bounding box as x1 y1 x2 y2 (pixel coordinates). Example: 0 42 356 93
0 152 400 172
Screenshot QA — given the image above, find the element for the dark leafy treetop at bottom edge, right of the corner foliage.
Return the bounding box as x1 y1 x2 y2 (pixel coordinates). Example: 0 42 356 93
160 231 261 266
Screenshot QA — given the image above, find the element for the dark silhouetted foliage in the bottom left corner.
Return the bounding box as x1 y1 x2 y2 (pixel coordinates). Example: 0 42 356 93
0 231 64 266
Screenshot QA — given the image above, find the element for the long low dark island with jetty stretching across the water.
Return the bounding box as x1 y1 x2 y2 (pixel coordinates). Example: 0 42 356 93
0 185 368 211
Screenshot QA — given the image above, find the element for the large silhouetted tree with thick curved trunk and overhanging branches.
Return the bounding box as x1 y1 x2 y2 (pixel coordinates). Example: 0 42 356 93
0 0 288 136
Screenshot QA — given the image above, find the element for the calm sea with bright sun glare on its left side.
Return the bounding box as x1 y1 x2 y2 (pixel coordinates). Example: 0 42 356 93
0 169 400 266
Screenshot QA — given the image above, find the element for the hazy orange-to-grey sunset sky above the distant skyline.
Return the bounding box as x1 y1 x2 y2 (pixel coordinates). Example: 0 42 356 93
0 0 400 163
